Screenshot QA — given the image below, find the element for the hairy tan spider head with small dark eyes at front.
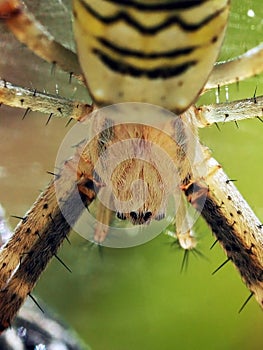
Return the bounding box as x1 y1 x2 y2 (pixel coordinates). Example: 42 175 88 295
112 159 169 225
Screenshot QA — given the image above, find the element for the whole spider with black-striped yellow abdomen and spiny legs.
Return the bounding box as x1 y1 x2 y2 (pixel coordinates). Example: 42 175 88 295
0 0 263 332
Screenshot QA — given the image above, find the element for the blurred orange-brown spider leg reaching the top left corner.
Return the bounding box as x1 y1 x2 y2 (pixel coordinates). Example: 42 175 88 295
0 0 84 81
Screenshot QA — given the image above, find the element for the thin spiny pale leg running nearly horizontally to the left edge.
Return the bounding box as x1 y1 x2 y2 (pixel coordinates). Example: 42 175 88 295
0 79 93 120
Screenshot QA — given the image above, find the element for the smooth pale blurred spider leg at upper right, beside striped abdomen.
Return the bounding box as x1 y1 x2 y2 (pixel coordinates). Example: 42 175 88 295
205 44 263 90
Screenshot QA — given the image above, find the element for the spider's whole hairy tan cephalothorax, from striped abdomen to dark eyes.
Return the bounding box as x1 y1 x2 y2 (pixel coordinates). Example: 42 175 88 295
76 110 199 224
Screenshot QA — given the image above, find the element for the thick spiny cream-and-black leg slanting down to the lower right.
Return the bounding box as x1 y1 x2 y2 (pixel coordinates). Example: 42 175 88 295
184 151 263 307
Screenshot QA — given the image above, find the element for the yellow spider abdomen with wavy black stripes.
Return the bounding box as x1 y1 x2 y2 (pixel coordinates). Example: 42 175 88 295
73 0 229 113
